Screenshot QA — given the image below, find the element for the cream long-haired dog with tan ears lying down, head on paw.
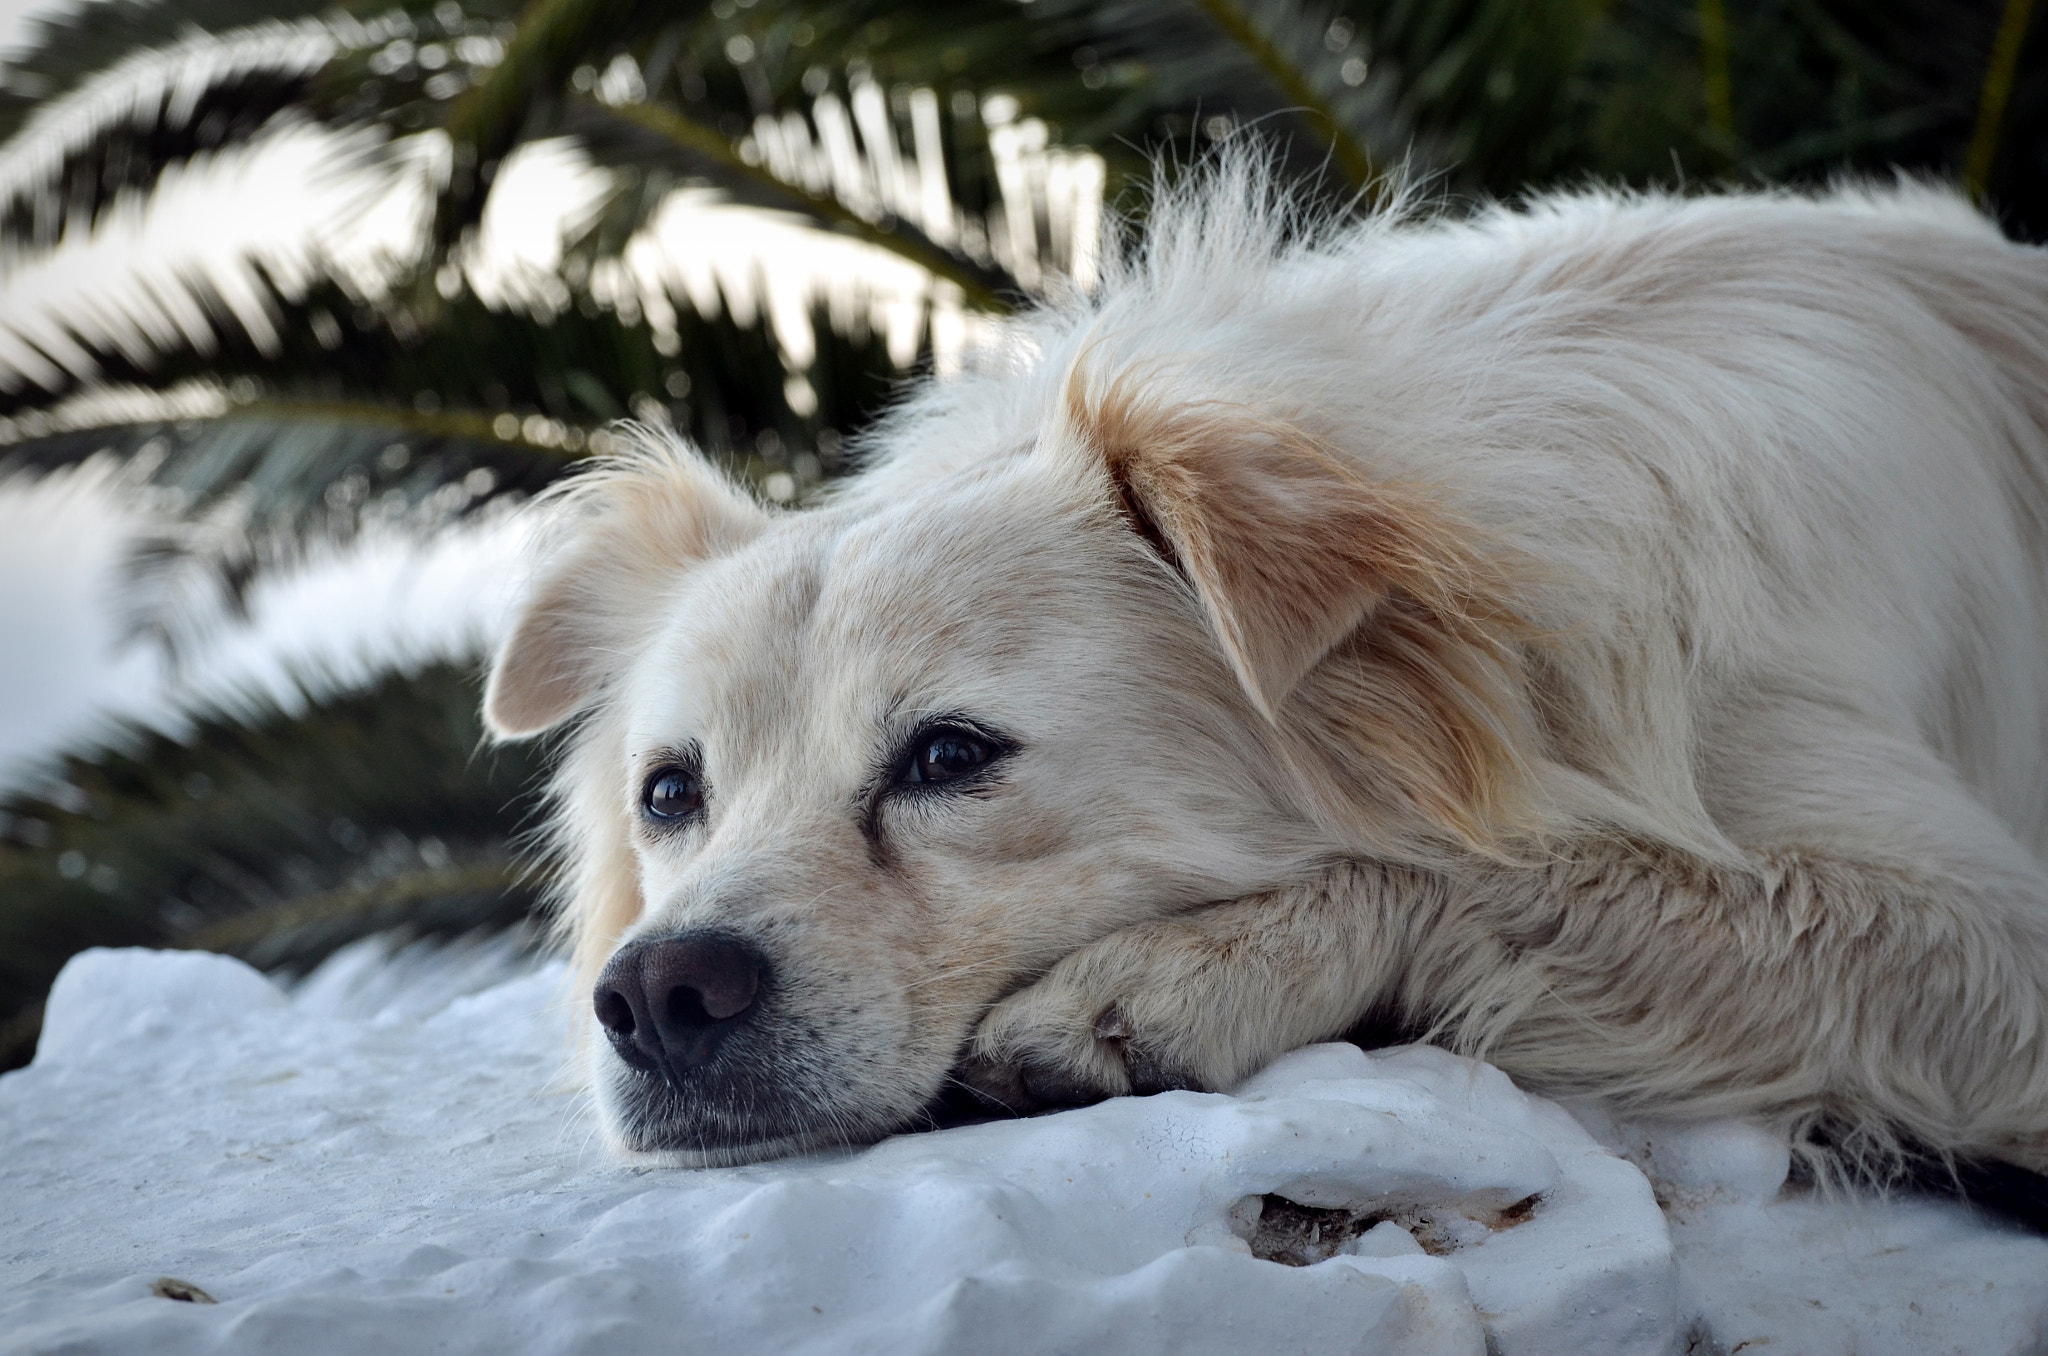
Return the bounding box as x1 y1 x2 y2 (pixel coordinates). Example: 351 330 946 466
485 156 2048 1172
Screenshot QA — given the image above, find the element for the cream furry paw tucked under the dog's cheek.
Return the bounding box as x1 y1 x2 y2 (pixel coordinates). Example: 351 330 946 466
956 924 1221 1112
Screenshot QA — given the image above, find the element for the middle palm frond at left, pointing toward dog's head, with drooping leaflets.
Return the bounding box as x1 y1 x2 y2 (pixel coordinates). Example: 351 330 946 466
0 256 905 660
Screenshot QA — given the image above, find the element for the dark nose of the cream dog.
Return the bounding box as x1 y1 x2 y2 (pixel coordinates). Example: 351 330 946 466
592 932 768 1084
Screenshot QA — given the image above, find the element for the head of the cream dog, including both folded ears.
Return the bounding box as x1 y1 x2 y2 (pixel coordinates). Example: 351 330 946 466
485 379 1526 1163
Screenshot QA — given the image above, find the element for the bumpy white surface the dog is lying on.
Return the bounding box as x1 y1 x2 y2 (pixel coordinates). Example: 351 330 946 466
0 940 2048 1356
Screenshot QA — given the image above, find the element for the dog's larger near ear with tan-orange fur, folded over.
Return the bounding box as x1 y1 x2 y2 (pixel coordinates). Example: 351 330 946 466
1067 367 1538 852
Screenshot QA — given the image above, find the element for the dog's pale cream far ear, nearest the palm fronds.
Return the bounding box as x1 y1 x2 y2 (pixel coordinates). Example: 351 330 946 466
483 442 768 739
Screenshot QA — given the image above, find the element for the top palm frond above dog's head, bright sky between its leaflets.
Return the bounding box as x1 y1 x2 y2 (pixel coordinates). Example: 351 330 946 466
438 0 1397 297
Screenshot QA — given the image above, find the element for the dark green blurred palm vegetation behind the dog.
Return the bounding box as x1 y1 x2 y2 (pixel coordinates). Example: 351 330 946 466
0 0 2048 1063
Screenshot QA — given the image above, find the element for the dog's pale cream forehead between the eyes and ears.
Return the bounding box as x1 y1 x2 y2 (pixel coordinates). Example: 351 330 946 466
631 462 1114 748
